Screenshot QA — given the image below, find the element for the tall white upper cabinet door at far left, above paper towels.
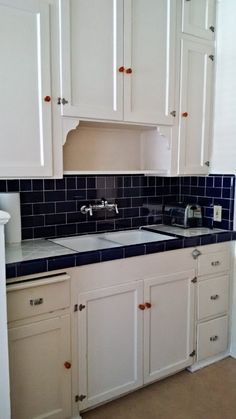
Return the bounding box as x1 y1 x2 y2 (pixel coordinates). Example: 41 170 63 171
0 0 52 177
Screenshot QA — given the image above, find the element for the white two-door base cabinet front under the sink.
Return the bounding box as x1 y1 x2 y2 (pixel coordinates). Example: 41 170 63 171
70 250 196 411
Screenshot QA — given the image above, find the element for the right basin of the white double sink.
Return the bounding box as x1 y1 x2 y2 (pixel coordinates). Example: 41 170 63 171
102 230 173 246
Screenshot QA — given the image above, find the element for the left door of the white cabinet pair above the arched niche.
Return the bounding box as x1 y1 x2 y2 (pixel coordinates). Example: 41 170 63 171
60 0 123 120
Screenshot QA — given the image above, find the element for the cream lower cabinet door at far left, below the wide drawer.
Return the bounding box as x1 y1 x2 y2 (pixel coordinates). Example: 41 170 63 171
9 315 71 419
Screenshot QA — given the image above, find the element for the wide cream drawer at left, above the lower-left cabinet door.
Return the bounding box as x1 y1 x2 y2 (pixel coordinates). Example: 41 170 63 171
7 274 70 322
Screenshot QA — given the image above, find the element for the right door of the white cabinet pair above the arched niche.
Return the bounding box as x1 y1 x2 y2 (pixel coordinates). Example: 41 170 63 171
124 0 176 125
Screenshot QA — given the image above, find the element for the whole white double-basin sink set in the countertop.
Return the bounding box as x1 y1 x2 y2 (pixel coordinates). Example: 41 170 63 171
50 230 174 252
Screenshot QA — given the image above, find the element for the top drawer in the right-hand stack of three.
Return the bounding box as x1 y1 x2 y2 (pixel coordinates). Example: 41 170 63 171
198 252 230 276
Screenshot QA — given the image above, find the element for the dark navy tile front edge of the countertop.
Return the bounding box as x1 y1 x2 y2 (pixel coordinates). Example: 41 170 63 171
6 231 236 278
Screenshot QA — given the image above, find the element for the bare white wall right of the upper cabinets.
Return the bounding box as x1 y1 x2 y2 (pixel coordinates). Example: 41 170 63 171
211 0 236 173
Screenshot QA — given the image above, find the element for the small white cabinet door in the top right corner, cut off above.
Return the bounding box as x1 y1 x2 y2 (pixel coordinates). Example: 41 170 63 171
182 0 216 41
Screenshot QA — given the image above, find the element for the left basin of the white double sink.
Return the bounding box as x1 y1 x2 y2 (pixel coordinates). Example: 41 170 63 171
50 233 121 252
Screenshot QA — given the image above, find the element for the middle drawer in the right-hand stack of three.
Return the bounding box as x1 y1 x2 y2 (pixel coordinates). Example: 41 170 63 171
197 275 229 320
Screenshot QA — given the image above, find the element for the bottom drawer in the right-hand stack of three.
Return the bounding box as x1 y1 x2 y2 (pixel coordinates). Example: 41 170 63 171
197 316 228 361
